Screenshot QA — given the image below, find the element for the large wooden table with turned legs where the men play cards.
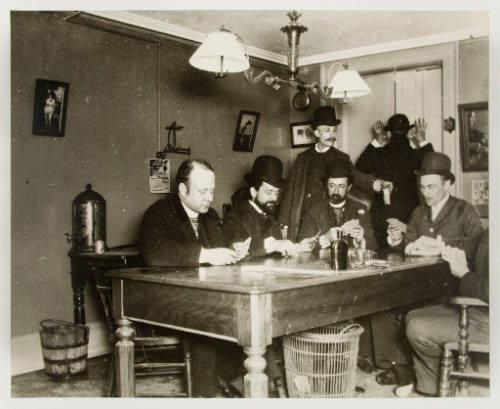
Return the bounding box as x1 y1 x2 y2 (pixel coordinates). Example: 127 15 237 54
106 252 457 397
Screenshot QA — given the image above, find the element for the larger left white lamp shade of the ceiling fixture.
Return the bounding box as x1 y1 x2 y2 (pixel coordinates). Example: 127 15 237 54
189 31 250 73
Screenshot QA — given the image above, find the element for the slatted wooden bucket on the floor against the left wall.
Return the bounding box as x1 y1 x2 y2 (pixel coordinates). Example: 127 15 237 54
40 319 89 377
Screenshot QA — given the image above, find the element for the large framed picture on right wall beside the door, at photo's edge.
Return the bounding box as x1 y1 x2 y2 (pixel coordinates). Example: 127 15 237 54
458 102 489 172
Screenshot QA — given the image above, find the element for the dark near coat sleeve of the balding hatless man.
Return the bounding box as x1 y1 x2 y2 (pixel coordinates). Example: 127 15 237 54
139 204 202 267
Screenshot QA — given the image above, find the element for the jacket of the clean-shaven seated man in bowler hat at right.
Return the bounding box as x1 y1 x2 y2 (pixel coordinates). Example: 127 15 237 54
404 196 483 266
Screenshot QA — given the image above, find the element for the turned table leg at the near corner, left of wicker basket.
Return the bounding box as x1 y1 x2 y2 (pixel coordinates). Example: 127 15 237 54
243 346 269 398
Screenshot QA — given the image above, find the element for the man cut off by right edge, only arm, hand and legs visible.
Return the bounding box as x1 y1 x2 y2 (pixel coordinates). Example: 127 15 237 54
406 230 489 396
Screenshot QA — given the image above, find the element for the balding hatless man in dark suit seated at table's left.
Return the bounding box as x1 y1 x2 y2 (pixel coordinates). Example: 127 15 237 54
140 159 243 397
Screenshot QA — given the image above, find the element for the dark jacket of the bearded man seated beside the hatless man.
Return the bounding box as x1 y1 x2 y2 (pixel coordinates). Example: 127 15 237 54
222 200 282 256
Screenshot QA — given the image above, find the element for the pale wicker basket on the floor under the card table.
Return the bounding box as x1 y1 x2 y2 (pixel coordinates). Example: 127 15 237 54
283 323 363 398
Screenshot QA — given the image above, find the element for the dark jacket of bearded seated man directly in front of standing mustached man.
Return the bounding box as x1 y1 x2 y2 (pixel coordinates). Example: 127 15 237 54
298 198 377 250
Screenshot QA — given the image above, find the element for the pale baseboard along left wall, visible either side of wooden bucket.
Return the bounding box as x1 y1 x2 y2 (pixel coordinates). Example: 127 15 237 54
11 322 112 376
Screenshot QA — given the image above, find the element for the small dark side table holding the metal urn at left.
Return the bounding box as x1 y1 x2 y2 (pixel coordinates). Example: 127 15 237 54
68 246 141 324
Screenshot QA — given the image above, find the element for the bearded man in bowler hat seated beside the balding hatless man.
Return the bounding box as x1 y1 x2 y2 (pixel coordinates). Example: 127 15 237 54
223 155 316 257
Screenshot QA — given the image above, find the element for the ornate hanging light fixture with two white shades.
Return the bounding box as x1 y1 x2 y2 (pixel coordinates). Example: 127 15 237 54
189 10 371 102
